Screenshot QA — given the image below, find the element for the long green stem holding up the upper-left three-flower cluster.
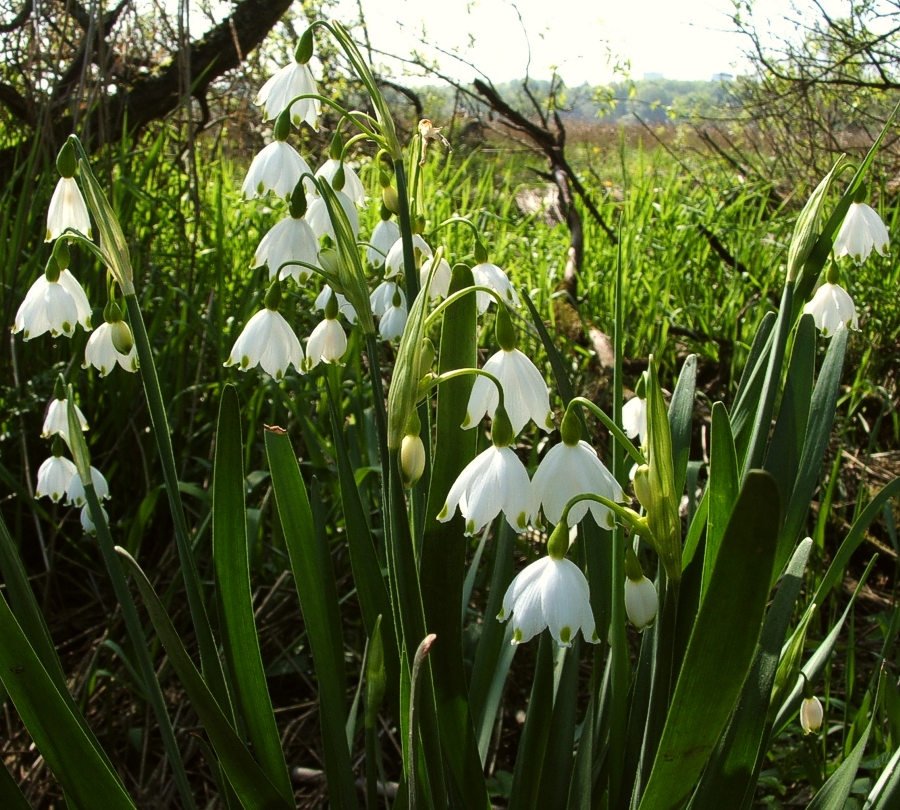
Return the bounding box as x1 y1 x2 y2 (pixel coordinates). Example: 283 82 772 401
125 293 233 722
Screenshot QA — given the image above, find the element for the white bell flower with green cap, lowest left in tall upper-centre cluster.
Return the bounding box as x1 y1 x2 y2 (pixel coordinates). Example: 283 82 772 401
225 279 303 380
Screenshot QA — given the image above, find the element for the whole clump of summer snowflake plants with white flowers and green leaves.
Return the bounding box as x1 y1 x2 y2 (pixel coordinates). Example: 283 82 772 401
0 22 900 810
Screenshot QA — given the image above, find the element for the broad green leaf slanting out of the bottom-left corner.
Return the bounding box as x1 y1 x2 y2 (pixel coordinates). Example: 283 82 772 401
0 580 135 810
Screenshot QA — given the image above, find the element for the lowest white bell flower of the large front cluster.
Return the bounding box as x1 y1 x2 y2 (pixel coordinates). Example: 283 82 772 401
497 556 599 647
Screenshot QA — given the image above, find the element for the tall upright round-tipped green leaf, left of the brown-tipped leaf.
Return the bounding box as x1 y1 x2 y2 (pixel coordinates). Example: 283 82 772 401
212 385 294 802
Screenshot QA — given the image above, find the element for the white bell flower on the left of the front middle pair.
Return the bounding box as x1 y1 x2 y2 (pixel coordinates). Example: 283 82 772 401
438 444 535 535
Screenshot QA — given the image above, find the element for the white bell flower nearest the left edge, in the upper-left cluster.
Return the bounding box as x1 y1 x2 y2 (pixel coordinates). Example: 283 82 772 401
13 268 91 340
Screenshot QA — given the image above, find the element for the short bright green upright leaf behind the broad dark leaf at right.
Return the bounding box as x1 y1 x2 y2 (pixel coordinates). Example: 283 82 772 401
700 402 741 600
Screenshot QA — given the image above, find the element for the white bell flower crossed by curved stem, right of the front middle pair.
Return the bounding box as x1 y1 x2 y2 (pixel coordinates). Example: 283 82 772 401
532 440 627 528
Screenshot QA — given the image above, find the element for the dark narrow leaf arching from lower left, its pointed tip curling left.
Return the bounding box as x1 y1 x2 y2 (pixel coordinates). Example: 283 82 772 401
115 546 293 810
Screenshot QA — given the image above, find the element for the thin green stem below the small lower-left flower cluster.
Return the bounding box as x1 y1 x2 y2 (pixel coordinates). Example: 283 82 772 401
81 474 197 808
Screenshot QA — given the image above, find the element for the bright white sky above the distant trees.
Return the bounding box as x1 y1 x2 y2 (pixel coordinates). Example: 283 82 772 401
339 0 847 86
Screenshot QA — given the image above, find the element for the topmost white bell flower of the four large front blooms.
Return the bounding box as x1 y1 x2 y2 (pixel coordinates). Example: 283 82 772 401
463 349 553 434
